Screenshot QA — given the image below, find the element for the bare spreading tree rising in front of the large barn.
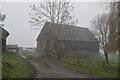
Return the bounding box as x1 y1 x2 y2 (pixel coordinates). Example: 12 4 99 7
29 1 77 53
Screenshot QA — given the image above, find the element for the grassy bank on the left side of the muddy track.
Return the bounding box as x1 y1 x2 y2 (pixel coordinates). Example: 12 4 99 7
2 54 33 78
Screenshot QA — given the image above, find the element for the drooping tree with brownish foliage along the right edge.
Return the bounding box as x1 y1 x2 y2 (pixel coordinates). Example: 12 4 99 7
108 2 118 52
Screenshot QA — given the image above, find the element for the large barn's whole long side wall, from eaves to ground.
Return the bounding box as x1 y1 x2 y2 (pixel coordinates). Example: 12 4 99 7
57 41 100 60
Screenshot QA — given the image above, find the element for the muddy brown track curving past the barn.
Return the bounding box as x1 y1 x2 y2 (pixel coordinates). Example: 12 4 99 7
21 56 101 78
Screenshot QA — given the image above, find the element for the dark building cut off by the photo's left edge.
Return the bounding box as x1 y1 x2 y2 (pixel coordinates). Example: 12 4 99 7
0 27 9 53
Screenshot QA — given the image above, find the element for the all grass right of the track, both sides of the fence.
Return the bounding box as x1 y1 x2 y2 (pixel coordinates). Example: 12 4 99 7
47 55 118 78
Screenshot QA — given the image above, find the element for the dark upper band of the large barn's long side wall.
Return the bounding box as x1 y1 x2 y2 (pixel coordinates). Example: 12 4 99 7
57 41 99 53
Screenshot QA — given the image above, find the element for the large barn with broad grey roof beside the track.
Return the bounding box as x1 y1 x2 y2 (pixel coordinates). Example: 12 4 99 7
36 22 99 58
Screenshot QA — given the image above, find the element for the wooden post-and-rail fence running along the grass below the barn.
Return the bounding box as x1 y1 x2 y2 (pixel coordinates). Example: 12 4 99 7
48 51 118 71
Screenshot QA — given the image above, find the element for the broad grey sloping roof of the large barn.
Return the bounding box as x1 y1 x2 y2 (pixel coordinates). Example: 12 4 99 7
37 22 98 42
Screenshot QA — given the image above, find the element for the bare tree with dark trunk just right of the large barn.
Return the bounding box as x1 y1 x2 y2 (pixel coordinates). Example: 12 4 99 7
91 14 109 64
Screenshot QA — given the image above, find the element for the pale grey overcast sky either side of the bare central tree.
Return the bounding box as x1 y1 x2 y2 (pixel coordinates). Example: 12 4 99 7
2 2 103 47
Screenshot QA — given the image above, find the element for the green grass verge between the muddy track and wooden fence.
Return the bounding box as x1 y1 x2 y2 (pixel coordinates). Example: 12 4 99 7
46 57 118 78
